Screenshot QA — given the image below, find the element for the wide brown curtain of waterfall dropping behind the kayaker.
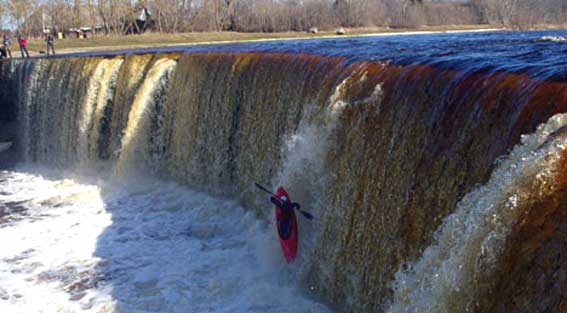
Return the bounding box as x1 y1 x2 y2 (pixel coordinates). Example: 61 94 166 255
3 52 567 312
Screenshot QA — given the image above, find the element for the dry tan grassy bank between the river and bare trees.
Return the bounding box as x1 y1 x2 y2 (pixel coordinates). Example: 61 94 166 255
5 25 502 57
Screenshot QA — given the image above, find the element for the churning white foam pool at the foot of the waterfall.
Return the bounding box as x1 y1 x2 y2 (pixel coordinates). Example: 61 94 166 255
0 169 330 313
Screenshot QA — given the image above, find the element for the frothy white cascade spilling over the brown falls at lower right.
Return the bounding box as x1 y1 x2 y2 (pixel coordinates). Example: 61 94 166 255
387 114 567 312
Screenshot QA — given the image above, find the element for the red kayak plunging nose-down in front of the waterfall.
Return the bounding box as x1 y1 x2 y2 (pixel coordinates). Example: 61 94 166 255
274 187 299 263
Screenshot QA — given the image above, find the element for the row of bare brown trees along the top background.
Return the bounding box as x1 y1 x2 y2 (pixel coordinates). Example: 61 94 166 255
0 0 567 36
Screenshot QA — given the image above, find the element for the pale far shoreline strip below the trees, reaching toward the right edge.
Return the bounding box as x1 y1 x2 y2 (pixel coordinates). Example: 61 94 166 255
4 25 562 57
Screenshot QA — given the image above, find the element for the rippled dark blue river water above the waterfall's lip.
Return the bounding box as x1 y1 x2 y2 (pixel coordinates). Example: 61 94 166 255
64 31 567 80
